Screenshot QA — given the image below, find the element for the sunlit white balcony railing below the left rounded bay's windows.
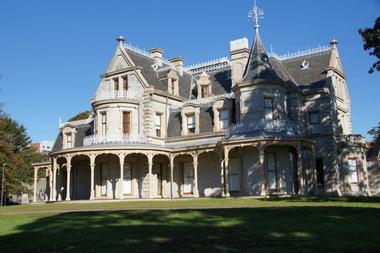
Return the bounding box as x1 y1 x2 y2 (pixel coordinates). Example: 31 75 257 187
83 134 148 146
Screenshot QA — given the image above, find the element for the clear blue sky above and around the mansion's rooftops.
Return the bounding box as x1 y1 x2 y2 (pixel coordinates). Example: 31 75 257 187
0 0 380 141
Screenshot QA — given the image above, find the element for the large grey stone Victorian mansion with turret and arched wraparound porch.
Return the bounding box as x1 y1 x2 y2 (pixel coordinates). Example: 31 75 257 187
34 8 370 201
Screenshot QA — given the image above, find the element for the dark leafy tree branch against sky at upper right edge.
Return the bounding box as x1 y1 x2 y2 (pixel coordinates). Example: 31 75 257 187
359 17 380 73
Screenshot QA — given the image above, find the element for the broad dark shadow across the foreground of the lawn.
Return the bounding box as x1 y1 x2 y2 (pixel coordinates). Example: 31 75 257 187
0 207 380 253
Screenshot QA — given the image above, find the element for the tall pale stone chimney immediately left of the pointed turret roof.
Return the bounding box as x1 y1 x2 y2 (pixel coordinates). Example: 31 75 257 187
230 38 249 86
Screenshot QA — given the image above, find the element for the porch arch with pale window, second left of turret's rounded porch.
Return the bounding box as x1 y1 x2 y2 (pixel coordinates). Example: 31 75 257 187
173 154 194 198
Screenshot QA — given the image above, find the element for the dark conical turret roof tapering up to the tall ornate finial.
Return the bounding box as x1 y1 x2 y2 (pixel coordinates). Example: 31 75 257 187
241 32 282 83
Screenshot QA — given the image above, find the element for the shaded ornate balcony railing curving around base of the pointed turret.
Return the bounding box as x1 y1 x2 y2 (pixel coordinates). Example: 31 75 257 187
225 120 300 138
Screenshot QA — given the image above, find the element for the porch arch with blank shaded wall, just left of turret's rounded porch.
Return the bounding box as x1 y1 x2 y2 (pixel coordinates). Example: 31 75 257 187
198 151 222 197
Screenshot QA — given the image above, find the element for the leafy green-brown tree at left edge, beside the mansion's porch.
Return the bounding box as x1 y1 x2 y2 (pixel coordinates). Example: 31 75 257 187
0 109 47 200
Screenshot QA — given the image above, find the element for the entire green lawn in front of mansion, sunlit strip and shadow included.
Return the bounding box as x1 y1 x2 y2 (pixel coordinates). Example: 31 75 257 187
0 197 380 253
